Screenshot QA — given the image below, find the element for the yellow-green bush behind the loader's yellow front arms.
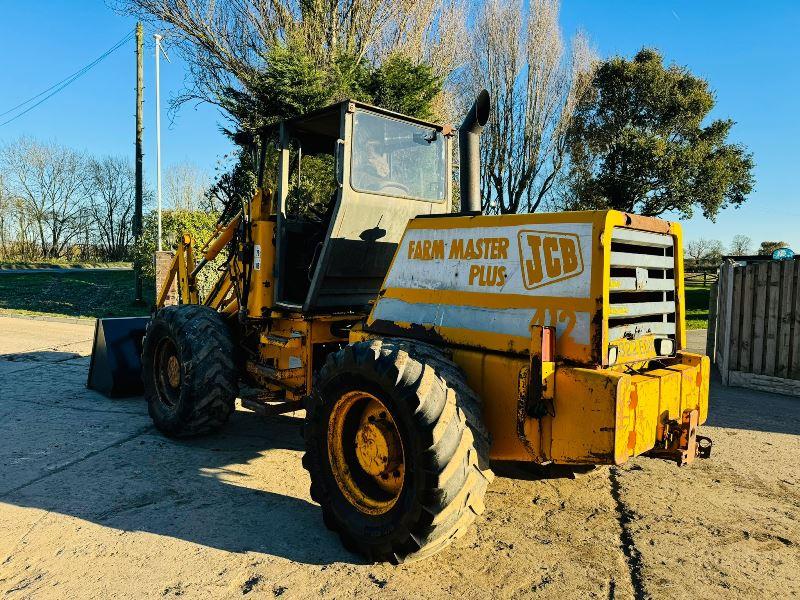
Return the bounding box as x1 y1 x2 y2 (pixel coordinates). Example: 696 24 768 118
132 210 227 299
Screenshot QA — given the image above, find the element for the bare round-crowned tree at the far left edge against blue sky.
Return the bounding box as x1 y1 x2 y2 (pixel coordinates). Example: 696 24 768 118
0 138 86 258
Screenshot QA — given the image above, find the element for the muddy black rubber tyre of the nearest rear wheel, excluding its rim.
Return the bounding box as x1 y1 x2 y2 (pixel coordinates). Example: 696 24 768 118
303 339 494 563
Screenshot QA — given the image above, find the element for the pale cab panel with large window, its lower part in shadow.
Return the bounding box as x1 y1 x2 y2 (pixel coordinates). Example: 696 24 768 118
303 102 451 312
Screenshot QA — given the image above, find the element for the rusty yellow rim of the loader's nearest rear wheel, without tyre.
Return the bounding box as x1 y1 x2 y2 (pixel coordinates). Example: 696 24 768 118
328 390 405 515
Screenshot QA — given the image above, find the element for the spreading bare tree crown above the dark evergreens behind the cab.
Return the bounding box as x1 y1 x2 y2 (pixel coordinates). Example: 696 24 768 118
117 0 465 119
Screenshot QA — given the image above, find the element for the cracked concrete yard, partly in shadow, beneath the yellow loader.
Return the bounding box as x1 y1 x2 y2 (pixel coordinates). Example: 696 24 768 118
0 317 800 598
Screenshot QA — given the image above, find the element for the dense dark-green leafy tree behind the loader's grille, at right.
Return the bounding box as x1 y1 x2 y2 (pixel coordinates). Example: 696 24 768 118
568 49 753 220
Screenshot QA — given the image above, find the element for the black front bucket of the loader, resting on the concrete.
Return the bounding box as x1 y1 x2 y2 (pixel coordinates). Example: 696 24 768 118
86 317 150 398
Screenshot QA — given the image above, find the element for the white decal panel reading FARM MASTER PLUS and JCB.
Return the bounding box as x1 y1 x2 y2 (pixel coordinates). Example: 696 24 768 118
385 223 592 298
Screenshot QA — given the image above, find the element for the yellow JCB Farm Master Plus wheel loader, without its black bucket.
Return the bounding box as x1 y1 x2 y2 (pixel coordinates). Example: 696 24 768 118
94 92 710 562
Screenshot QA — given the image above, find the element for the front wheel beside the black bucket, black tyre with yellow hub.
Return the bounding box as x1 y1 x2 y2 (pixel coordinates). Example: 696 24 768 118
142 304 238 437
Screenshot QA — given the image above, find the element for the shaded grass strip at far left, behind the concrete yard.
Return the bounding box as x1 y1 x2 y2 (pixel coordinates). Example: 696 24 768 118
0 269 154 318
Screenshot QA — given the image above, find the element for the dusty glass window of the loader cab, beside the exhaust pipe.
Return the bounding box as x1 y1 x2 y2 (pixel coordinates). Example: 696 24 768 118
350 111 445 202
